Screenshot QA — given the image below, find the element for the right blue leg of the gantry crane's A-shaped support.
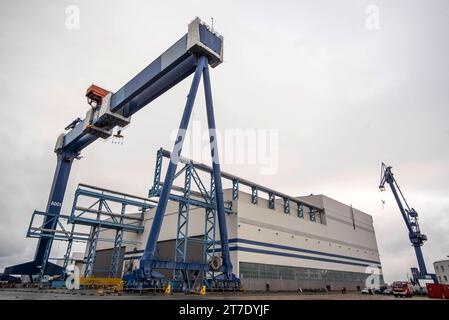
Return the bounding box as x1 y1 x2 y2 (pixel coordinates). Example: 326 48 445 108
203 63 232 279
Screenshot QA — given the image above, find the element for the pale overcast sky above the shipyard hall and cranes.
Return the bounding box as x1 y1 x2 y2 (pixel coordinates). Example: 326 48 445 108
0 0 449 281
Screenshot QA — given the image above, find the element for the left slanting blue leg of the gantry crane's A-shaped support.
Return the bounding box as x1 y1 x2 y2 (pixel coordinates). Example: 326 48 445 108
140 56 207 276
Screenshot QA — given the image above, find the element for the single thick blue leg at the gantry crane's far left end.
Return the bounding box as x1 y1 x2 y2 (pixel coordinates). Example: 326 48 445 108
34 152 74 275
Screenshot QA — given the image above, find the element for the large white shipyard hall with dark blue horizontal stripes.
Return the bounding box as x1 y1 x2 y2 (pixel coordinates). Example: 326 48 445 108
90 181 383 290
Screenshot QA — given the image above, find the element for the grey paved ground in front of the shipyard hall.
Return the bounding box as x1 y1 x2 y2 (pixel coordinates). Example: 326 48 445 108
0 289 429 300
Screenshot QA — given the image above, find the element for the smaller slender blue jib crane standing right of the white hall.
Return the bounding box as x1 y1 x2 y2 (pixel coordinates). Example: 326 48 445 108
379 162 434 281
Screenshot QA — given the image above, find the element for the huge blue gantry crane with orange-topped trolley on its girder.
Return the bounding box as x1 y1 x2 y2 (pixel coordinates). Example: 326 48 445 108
4 18 238 283
